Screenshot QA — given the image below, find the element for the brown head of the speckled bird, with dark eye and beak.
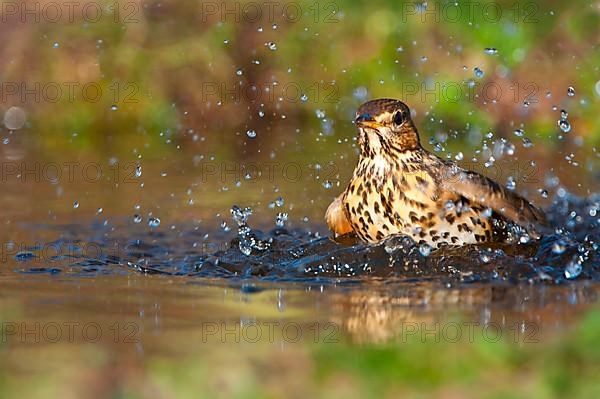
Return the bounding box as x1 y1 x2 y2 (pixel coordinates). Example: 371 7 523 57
354 98 421 156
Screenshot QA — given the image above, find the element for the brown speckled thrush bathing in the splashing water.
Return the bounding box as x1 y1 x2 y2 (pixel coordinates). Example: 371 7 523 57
325 98 548 248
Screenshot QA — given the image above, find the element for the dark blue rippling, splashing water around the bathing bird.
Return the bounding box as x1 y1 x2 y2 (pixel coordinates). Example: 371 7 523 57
7 194 600 285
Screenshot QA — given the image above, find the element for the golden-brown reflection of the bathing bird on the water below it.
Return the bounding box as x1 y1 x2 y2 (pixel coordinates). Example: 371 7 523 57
334 284 597 342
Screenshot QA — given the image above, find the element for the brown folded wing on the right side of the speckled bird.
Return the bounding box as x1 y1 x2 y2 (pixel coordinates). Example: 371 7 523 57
440 161 548 227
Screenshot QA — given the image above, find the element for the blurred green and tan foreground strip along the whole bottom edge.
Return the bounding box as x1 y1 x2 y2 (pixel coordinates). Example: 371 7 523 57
0 309 600 399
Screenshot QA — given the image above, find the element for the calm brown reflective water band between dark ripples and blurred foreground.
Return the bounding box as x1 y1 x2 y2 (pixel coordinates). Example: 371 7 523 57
0 275 598 346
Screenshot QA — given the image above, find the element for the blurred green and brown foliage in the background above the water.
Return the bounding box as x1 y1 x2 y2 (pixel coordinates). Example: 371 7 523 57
0 0 600 158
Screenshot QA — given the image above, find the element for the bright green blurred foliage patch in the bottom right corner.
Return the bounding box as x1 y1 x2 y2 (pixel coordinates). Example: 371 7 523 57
314 311 600 398
